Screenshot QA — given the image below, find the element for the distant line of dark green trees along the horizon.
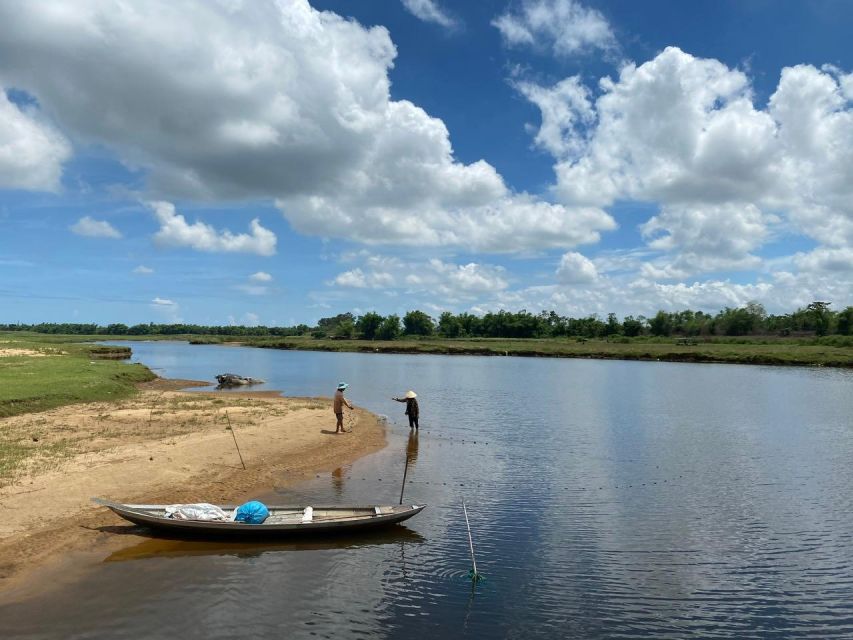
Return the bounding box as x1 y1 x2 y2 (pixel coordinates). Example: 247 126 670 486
6 301 853 340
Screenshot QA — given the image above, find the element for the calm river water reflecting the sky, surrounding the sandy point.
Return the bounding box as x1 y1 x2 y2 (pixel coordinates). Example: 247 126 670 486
0 343 853 640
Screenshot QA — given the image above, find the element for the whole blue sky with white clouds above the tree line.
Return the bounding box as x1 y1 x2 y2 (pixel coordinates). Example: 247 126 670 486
0 0 853 326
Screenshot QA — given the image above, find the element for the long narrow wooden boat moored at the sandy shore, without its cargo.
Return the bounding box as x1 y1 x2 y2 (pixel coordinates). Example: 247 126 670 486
92 498 426 538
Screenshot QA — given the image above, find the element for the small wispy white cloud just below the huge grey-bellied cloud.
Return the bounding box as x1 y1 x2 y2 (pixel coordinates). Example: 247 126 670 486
148 201 277 256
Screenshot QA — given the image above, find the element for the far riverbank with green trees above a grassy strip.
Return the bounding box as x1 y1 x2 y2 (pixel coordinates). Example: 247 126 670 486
0 302 853 367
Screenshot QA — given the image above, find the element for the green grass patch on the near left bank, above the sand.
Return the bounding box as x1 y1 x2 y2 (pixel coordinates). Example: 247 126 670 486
0 333 156 417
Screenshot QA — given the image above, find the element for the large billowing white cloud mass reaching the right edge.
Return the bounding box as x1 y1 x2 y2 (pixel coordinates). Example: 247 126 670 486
515 47 853 278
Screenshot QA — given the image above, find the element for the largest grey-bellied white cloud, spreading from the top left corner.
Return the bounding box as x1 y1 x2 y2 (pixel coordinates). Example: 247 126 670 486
0 0 614 251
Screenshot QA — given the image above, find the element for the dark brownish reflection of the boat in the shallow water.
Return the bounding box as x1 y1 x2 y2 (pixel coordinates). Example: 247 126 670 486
104 527 425 562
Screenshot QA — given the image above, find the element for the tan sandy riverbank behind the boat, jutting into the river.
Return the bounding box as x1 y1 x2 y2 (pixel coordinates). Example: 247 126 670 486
0 380 385 591
